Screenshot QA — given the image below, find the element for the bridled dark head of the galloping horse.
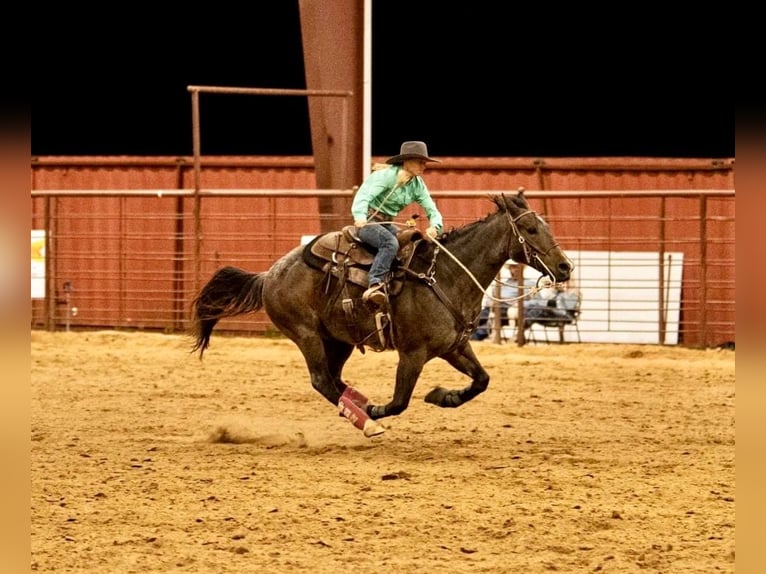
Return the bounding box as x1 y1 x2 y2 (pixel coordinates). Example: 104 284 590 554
494 190 574 283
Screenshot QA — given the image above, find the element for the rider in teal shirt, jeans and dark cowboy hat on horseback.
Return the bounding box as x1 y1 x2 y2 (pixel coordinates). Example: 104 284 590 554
351 141 443 305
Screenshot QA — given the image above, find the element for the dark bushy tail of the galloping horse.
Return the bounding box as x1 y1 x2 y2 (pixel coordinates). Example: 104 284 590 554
191 266 264 359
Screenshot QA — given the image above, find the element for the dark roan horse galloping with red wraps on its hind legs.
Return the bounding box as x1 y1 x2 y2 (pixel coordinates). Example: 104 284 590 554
192 191 573 437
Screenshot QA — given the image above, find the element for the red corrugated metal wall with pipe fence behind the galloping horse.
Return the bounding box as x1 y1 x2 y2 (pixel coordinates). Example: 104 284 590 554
31 189 735 346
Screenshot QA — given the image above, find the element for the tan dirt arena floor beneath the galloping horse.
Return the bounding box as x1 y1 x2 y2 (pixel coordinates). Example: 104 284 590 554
31 331 735 574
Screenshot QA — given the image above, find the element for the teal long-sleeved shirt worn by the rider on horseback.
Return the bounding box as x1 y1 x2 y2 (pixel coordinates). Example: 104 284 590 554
351 165 444 233
